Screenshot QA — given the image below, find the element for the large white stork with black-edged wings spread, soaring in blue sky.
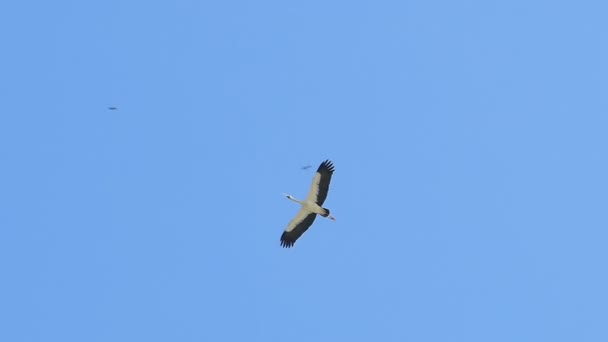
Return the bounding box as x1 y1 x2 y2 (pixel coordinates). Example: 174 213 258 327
281 160 336 248
